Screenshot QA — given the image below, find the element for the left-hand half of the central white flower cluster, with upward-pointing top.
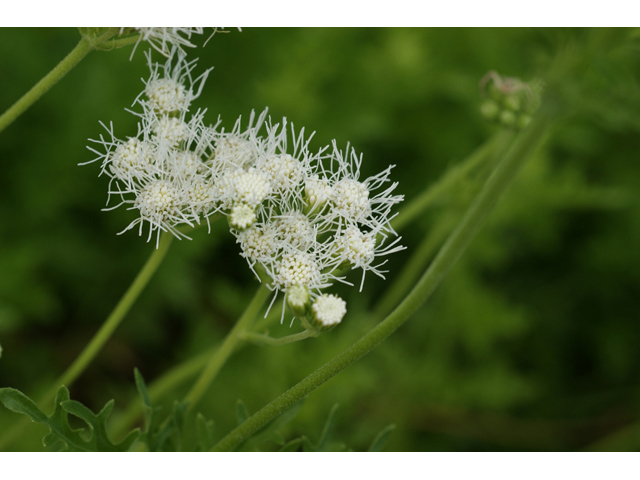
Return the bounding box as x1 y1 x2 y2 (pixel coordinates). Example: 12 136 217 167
89 51 216 245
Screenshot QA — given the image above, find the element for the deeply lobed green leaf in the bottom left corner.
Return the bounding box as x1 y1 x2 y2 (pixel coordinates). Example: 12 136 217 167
0 386 139 452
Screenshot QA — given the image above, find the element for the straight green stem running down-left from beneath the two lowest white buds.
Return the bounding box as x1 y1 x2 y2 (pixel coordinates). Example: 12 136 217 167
185 281 270 410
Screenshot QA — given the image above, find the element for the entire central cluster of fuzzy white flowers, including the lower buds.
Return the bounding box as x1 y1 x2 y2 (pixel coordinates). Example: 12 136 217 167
91 49 404 329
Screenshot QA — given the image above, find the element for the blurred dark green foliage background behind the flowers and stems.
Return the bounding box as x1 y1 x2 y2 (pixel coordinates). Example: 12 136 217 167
0 28 640 451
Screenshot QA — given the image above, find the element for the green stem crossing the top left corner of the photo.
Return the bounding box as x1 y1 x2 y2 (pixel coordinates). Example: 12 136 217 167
0 38 94 132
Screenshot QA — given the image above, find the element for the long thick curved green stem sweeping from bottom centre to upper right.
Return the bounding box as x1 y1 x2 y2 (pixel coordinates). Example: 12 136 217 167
212 109 551 451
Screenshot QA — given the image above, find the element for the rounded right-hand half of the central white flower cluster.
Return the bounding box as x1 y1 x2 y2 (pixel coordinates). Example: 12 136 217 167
230 120 404 325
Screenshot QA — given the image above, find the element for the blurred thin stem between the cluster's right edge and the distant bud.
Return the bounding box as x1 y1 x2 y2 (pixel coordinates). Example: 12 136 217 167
391 129 514 230
